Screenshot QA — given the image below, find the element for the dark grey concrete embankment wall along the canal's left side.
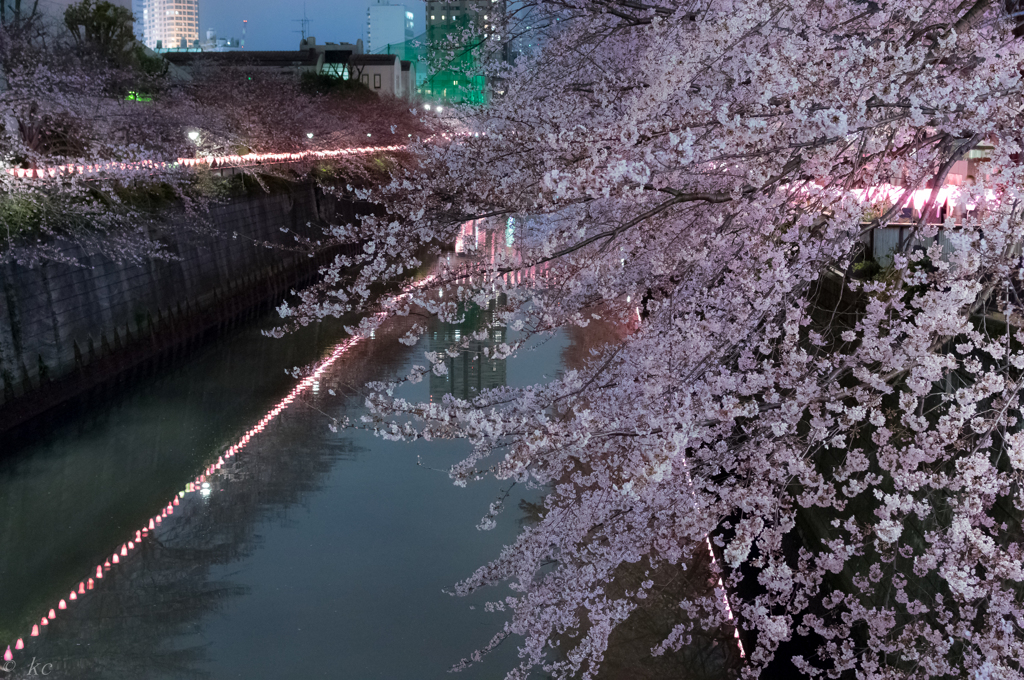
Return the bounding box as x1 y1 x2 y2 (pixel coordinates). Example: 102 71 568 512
0 184 367 432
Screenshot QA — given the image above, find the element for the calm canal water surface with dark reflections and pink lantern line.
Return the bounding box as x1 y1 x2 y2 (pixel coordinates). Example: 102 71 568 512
0 268 569 680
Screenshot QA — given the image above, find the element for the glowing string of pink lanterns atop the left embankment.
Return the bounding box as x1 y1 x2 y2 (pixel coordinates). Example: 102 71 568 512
7 144 406 179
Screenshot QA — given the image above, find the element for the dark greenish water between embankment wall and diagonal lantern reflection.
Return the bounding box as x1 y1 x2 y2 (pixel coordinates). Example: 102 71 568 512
0 311 356 649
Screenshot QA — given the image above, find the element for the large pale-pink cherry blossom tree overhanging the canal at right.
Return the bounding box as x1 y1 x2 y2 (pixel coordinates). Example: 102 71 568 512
281 0 1024 678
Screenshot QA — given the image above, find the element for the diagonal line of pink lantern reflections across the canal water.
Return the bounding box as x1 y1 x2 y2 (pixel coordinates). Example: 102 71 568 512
3 275 435 662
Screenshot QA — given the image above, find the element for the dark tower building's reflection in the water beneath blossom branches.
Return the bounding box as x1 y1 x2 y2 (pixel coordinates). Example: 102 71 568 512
430 296 507 402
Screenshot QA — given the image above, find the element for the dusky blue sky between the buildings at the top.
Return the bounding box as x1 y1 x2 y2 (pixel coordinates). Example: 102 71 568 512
134 0 426 50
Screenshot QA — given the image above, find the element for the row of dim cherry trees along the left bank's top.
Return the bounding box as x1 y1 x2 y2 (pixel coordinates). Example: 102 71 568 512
0 13 420 265
